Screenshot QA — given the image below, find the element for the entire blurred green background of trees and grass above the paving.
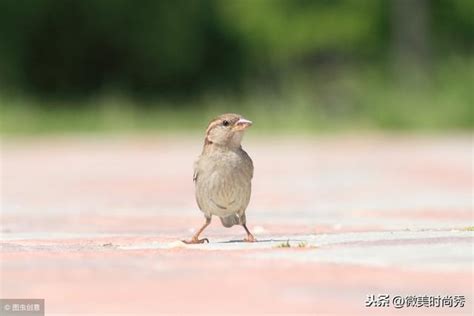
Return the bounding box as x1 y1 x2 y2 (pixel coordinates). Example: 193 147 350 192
0 0 474 135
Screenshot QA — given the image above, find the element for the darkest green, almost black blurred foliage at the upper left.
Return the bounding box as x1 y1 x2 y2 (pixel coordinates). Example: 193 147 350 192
0 0 246 95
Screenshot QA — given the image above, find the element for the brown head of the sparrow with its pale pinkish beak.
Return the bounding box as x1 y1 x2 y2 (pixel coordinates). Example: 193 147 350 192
204 113 252 148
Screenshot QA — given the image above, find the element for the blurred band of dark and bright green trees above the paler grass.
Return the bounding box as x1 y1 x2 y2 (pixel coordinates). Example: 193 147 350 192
0 0 474 100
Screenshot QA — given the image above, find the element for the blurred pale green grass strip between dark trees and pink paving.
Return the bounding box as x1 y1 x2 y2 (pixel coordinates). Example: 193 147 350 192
0 55 474 134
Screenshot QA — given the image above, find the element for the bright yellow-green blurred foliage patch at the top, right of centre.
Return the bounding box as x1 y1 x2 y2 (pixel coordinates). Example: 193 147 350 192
218 0 386 64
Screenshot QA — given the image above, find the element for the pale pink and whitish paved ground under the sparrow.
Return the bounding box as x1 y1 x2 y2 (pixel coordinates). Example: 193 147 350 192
0 135 474 315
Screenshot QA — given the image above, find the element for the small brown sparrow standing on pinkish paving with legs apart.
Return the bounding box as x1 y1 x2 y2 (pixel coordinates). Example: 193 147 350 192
184 113 255 244
